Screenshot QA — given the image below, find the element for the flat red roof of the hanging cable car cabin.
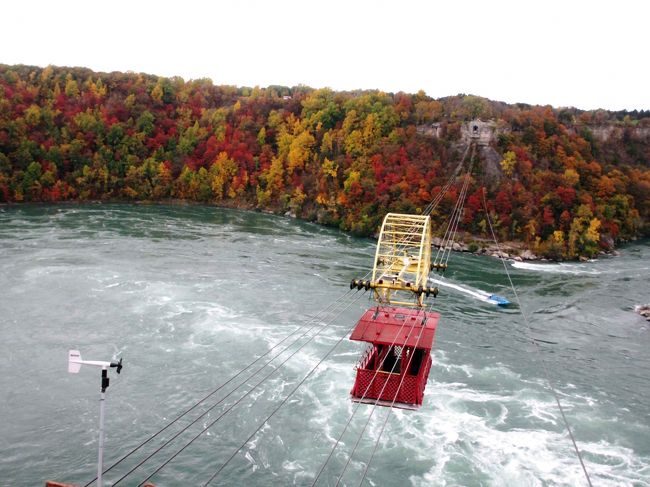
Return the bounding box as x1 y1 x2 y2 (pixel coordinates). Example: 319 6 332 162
350 306 440 350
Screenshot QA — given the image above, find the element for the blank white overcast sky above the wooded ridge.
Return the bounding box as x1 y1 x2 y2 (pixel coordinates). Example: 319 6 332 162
0 0 650 110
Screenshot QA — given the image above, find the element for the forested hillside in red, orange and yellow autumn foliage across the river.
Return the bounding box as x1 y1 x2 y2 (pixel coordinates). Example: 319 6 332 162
0 65 650 258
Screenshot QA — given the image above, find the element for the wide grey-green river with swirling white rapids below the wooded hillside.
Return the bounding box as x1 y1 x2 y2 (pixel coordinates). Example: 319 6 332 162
0 204 650 487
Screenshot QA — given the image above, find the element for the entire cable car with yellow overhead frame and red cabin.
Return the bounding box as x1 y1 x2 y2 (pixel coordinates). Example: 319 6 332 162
350 213 440 409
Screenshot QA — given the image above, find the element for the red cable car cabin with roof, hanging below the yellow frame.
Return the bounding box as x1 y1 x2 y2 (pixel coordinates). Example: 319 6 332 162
350 306 440 409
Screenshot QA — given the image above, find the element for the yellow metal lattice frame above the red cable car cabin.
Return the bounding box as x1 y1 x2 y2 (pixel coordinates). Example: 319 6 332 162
371 213 431 307
